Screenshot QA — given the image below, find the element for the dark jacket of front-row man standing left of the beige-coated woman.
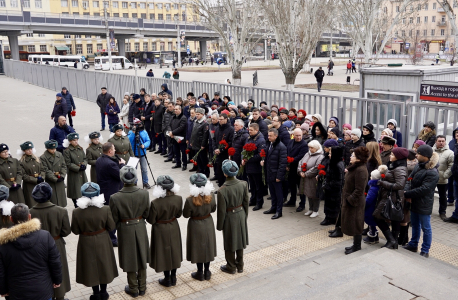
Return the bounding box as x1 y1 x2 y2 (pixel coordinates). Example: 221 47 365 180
264 137 288 183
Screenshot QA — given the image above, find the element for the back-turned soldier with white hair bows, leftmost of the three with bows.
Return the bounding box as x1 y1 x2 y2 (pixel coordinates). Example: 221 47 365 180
71 182 118 300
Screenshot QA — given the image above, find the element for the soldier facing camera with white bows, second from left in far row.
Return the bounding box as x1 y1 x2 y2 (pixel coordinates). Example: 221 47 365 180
17 141 45 208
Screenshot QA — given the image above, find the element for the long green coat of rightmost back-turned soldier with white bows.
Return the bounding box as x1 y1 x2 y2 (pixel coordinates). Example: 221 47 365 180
183 194 216 264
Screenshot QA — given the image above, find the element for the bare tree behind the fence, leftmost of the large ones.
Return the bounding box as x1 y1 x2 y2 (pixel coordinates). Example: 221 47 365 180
180 0 263 85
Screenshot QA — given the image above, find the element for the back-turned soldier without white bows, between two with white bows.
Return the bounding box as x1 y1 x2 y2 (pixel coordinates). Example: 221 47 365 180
110 166 150 297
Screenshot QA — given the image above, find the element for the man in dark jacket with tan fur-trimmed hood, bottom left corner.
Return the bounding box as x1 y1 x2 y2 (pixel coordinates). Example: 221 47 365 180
0 203 62 300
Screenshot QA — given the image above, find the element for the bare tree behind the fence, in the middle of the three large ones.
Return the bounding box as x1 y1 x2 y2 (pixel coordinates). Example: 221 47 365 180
258 0 335 90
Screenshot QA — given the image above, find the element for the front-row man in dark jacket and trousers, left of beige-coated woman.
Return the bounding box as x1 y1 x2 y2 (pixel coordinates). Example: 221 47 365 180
261 128 288 220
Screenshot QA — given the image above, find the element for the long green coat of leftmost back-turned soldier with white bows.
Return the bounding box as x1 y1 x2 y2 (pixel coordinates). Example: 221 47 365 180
72 205 118 287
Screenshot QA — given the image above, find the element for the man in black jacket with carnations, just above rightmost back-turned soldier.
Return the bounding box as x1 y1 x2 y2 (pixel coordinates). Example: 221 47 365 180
213 113 234 186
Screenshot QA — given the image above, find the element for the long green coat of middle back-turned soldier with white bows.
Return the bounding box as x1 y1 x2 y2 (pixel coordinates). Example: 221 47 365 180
147 195 183 272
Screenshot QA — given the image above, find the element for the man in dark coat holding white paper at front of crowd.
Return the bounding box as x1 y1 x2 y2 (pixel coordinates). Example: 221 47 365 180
169 105 188 171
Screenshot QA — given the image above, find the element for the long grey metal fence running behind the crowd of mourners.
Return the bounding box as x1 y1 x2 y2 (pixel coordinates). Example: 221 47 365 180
5 60 458 147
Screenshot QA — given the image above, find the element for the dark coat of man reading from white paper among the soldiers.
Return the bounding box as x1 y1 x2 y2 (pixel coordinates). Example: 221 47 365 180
95 154 127 205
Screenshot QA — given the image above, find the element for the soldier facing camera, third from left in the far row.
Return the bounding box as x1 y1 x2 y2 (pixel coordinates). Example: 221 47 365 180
40 140 67 207
